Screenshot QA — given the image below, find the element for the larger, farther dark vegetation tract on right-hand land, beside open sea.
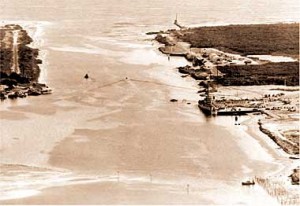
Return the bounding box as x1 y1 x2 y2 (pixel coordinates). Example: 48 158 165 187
177 23 299 58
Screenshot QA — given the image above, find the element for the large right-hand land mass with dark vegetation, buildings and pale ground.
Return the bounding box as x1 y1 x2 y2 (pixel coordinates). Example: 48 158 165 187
155 23 300 203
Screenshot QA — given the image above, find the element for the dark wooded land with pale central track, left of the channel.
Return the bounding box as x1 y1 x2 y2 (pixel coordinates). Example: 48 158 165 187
0 24 51 100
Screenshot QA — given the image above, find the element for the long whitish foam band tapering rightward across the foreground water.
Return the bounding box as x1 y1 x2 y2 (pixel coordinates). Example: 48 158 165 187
0 164 221 201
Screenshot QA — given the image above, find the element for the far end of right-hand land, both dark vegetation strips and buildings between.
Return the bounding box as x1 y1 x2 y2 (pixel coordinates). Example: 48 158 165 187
155 23 299 86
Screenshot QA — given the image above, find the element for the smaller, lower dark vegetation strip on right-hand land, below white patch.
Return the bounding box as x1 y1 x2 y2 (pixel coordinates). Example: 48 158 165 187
217 62 299 86
